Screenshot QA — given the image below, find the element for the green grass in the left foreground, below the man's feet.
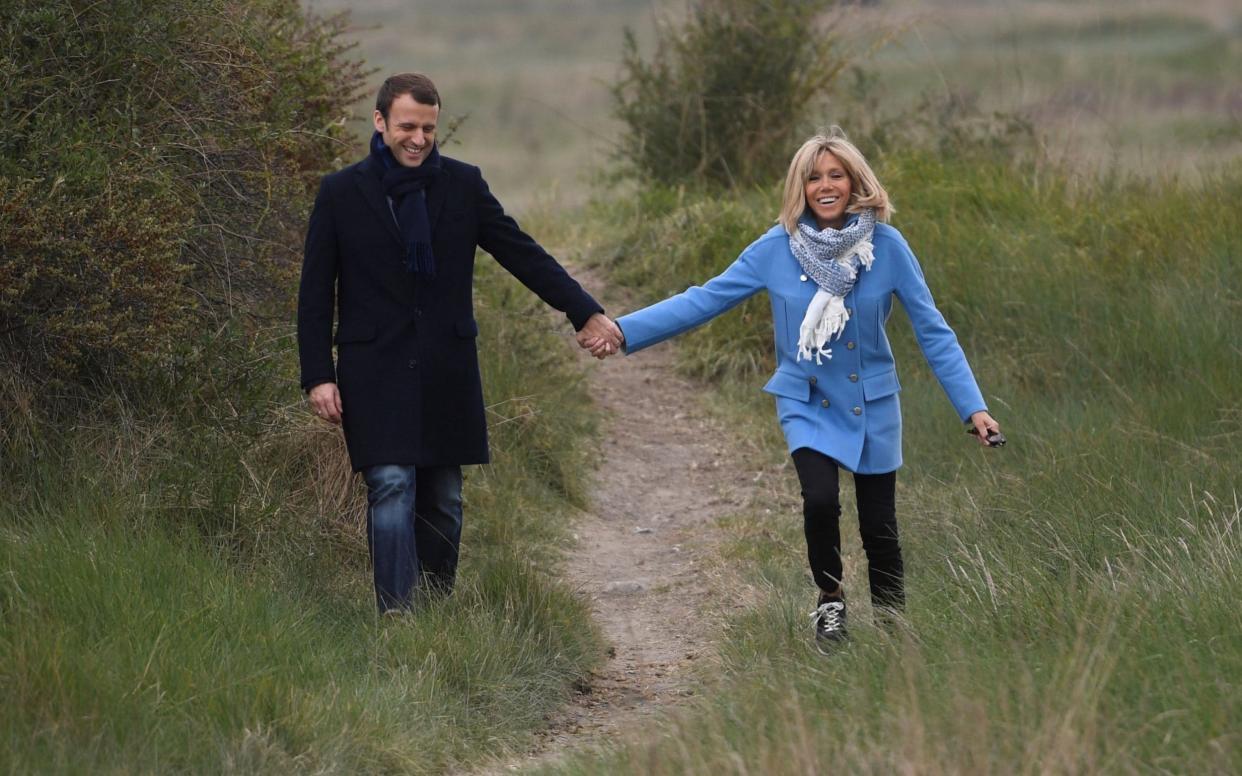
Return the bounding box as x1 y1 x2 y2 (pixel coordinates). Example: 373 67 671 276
0 505 590 772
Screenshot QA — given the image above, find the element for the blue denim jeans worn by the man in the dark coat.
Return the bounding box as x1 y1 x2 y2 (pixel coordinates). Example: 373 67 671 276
363 464 462 612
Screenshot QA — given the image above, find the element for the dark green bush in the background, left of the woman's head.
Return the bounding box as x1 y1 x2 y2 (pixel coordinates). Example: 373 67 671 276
612 0 847 185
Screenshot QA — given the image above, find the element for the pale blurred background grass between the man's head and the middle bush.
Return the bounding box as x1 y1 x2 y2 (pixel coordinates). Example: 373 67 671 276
307 0 670 212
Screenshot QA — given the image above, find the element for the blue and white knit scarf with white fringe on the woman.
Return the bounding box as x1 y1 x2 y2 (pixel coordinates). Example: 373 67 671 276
789 207 876 364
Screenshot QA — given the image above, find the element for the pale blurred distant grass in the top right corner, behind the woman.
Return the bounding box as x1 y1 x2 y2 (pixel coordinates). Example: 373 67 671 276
854 0 1242 179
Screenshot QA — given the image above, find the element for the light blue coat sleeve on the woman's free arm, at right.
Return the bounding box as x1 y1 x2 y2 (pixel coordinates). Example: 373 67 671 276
894 238 987 421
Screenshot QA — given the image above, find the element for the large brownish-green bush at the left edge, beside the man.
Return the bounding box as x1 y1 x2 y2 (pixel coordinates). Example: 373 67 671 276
0 0 364 397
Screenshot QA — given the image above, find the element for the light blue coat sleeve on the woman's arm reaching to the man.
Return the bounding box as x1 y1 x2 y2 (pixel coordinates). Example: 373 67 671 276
617 243 766 354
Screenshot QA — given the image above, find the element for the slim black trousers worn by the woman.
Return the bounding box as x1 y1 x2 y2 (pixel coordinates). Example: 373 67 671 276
794 447 905 610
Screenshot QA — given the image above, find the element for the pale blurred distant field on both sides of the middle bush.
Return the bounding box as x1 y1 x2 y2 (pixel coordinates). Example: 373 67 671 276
309 0 1242 204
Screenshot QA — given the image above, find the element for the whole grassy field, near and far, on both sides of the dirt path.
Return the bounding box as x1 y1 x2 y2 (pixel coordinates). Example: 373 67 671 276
0 0 1242 775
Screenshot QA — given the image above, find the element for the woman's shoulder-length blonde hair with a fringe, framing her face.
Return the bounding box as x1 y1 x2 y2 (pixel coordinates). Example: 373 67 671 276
776 127 897 235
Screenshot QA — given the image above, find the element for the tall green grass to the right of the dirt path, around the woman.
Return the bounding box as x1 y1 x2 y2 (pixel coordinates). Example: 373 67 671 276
548 145 1242 774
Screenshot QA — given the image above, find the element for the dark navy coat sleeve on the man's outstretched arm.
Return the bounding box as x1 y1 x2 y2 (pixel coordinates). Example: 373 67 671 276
474 168 604 330
